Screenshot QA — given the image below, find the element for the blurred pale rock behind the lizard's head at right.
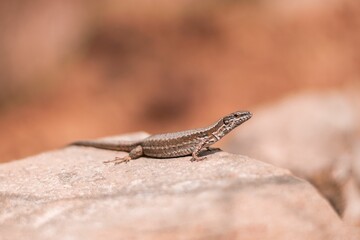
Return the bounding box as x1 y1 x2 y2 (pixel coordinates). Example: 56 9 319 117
225 91 360 226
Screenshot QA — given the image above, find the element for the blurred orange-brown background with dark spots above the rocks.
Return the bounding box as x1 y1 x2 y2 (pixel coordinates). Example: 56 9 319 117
0 0 360 162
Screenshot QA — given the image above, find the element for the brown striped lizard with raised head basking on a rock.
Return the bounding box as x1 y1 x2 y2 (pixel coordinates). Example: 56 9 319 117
70 111 252 164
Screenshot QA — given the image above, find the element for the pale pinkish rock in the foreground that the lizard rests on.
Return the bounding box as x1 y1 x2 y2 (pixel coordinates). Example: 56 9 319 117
0 134 356 239
